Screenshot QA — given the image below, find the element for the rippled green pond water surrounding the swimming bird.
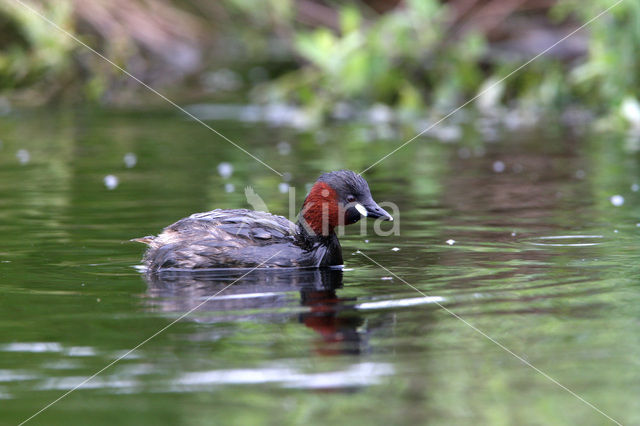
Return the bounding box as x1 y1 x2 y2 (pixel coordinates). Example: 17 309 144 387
0 110 640 425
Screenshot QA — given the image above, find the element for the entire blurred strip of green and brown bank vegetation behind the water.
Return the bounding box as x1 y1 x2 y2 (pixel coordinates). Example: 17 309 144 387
0 0 640 130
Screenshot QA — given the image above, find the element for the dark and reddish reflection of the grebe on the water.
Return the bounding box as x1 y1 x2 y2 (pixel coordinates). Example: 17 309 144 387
145 269 366 356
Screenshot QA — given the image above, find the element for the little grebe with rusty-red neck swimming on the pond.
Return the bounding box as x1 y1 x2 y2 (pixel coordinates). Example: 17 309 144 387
132 170 393 271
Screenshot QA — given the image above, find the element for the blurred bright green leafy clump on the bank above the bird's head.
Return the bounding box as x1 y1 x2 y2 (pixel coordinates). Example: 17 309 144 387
252 0 486 115
